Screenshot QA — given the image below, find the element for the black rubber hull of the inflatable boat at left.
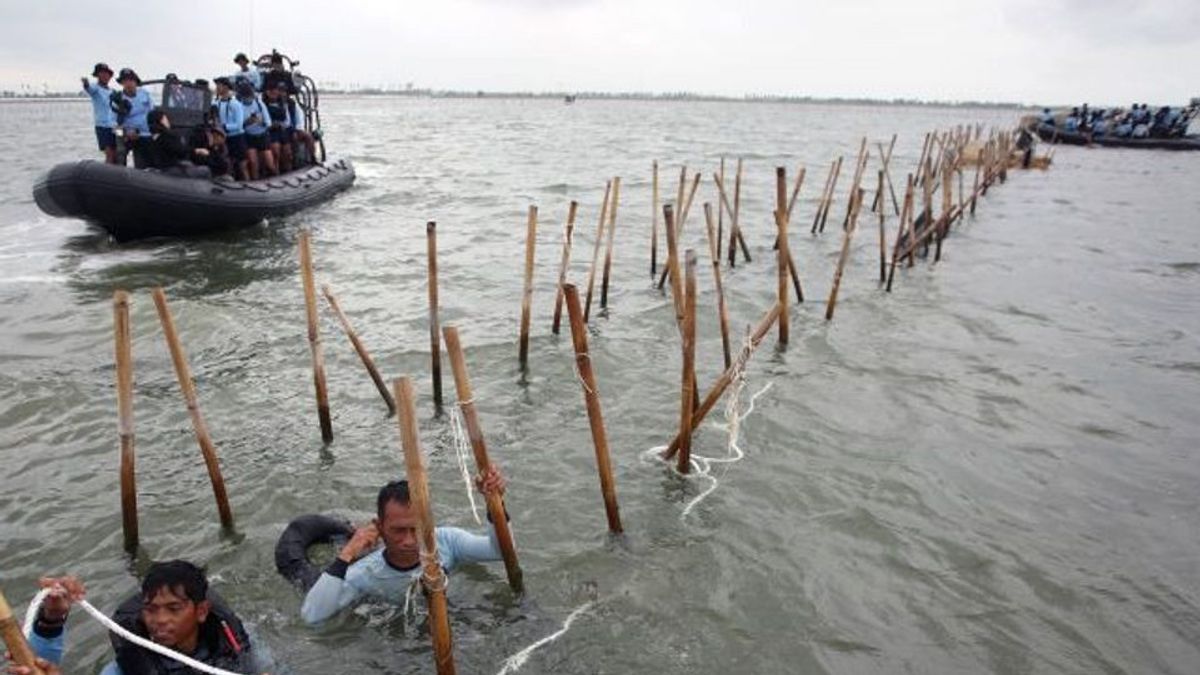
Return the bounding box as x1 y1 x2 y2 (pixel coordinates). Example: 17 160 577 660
34 159 354 241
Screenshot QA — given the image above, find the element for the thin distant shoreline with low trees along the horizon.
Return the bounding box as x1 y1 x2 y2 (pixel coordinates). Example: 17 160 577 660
0 89 1037 110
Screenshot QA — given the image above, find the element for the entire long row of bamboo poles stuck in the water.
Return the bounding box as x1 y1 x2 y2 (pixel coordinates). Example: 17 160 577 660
0 120 1049 675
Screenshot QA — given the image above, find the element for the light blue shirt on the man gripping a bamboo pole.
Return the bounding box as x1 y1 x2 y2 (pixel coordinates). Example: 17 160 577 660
300 527 500 625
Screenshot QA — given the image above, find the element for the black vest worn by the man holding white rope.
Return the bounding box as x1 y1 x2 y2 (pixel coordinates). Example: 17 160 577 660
110 590 260 675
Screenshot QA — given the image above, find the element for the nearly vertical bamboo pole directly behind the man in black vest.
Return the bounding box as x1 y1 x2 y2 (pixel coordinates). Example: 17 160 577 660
113 291 138 552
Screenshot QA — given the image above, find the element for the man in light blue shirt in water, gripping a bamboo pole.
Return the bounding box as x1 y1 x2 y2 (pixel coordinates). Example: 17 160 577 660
300 466 505 625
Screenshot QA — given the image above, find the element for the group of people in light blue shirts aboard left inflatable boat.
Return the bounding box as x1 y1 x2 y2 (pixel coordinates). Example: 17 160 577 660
82 52 317 180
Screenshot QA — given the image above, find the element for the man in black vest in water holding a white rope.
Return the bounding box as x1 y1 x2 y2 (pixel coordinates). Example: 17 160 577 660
8 560 271 675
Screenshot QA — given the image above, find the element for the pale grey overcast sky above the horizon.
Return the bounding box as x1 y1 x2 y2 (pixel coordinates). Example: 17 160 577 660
0 0 1200 104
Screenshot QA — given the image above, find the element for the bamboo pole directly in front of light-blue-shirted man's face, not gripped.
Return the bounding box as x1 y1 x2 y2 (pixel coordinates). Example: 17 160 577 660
392 377 455 675
